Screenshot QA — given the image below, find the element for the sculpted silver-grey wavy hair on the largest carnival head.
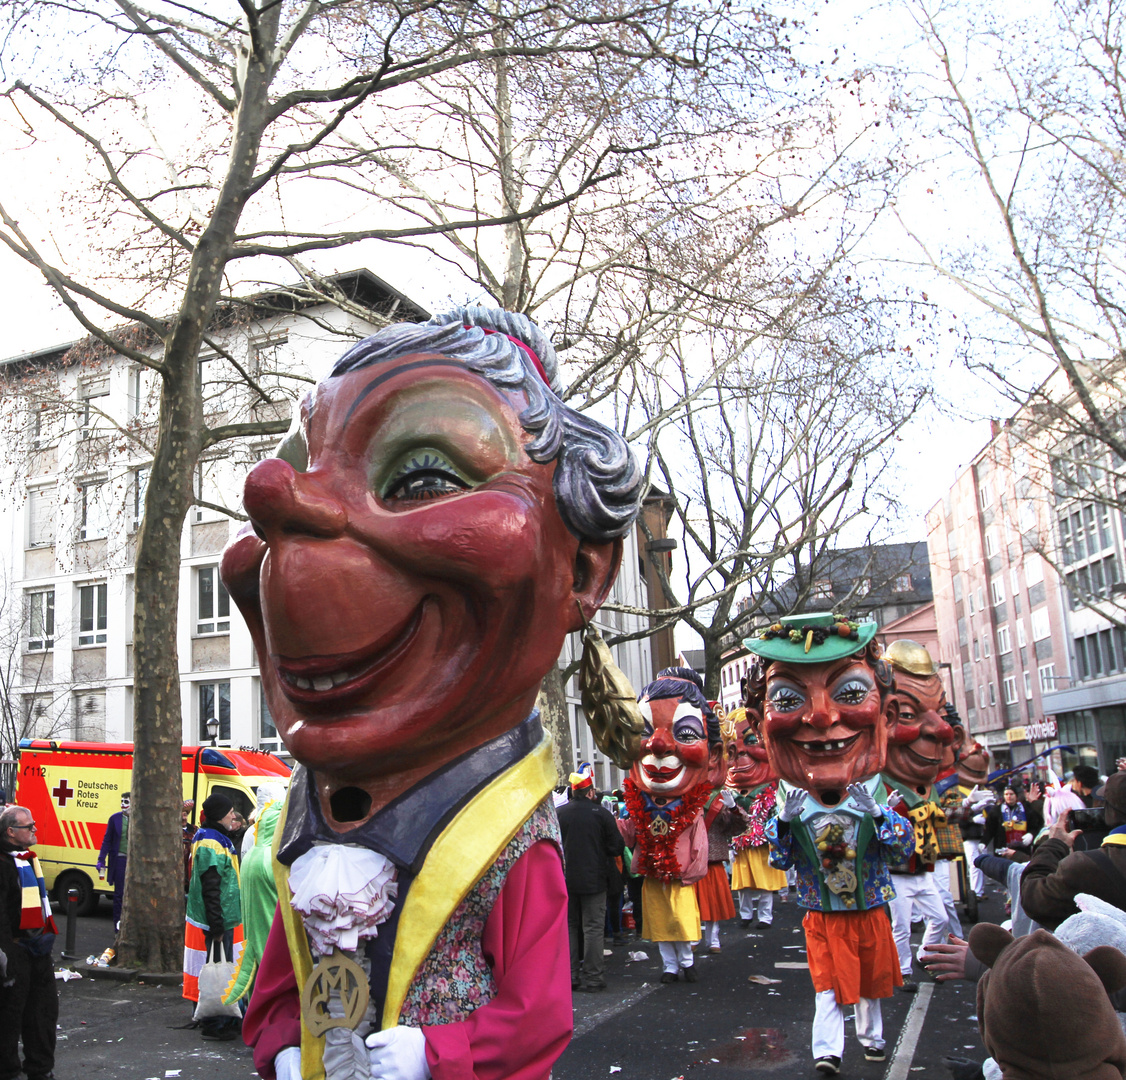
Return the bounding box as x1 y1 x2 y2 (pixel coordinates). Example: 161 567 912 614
329 307 644 543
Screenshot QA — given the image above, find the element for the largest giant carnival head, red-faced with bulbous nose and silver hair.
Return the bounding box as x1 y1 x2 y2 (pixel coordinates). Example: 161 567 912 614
222 309 642 802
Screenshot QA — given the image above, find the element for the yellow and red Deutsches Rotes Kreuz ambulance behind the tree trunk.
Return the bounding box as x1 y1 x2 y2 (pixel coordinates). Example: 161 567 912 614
16 739 289 914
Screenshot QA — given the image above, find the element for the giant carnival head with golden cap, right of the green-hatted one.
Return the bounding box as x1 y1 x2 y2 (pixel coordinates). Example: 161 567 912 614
884 639 963 795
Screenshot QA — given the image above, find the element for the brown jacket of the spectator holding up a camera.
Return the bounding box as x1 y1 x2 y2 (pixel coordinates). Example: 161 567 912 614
1020 839 1126 930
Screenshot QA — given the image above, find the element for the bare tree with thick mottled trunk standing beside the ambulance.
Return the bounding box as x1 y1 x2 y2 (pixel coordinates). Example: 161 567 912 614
0 0 783 971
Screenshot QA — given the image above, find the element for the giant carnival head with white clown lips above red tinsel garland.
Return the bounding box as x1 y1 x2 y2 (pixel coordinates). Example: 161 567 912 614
629 668 723 801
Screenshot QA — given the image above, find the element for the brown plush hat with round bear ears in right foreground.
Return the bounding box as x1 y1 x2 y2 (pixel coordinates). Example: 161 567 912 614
969 922 1126 1080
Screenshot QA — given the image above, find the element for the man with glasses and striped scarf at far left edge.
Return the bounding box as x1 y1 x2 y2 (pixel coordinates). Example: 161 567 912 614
0 805 59 1080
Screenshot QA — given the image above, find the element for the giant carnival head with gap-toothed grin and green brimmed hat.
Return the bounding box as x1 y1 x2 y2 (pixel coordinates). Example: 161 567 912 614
744 614 899 806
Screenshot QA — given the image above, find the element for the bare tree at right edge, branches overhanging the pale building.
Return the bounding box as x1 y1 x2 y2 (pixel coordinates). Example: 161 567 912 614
904 0 1126 627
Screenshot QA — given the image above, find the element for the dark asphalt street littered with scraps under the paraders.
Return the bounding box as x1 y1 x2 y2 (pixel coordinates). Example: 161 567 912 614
55 894 1004 1080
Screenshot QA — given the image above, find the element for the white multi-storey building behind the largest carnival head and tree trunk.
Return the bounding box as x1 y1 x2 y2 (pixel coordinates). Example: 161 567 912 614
0 271 651 784
